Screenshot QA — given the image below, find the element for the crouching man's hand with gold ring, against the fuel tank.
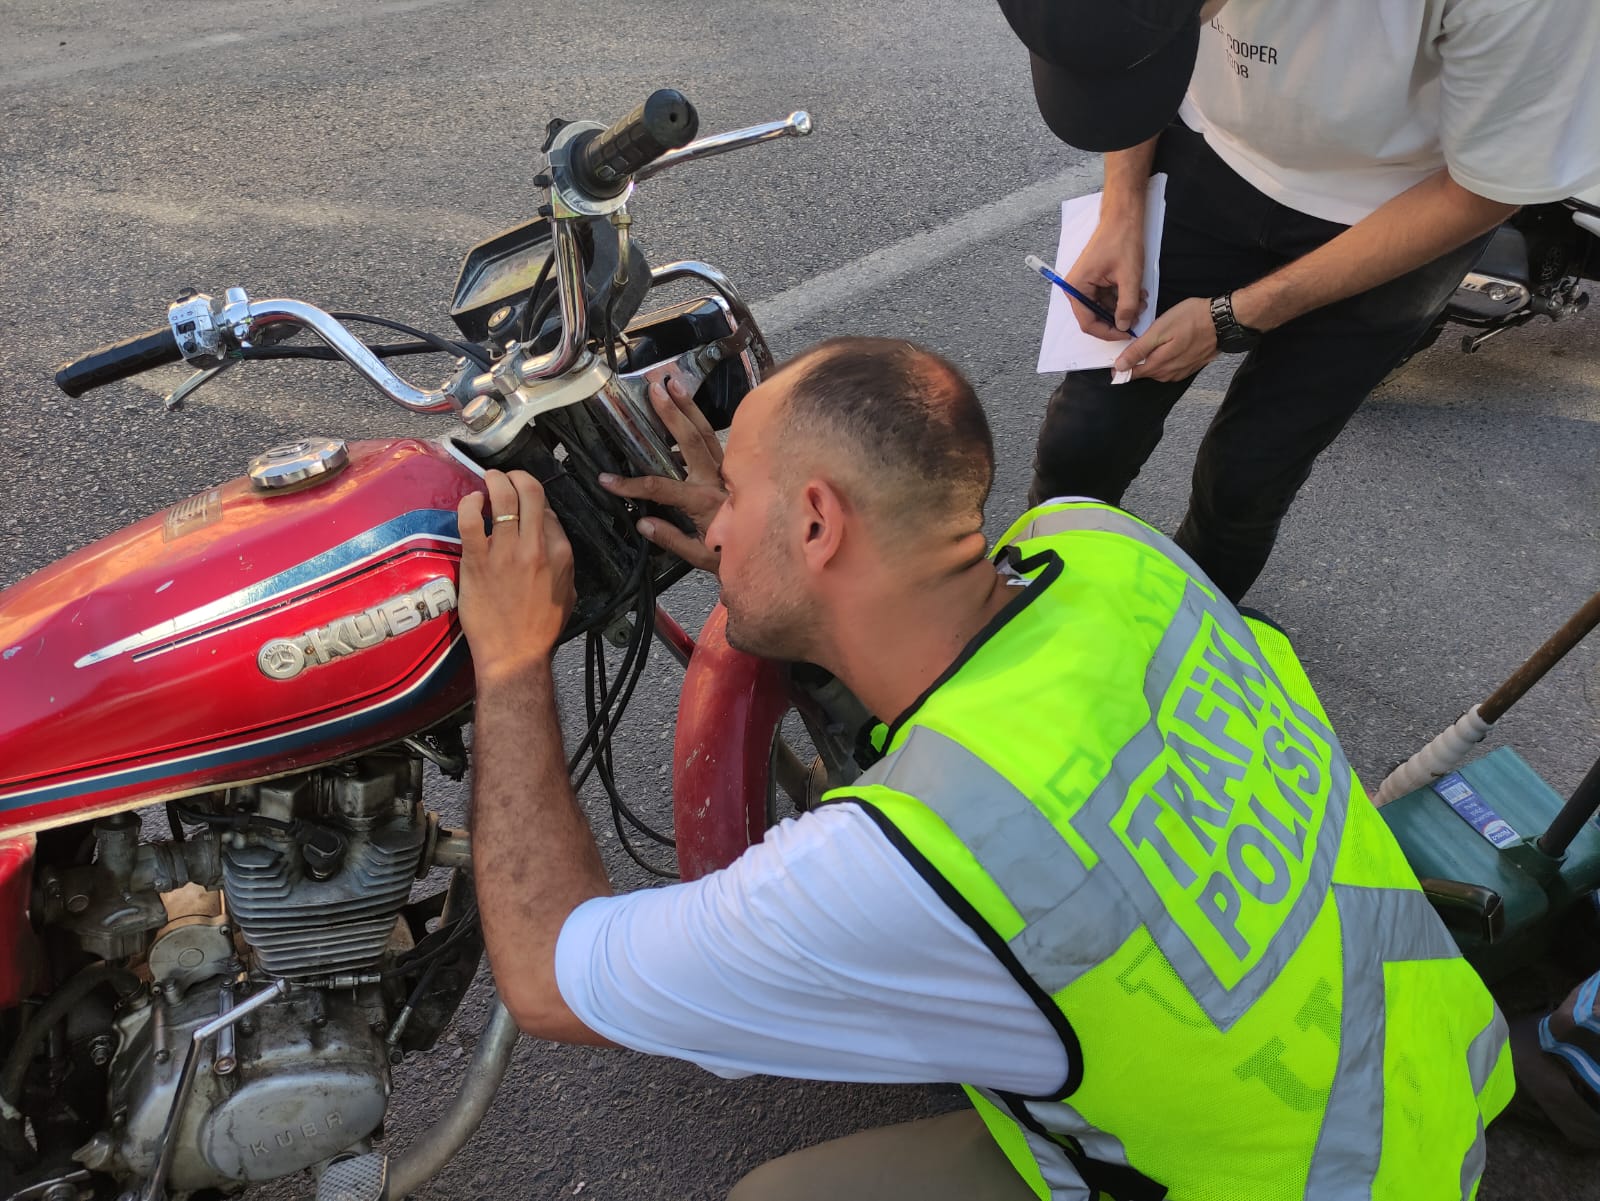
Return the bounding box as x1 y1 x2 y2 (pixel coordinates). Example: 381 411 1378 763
456 472 576 683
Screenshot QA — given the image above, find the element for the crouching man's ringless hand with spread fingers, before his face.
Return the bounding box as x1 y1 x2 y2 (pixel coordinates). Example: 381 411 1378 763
600 376 728 574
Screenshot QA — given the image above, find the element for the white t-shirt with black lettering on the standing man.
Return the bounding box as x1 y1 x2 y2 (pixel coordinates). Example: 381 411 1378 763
1179 0 1600 224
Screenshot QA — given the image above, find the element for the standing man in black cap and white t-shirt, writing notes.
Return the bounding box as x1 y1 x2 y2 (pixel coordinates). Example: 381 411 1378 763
1000 0 1600 601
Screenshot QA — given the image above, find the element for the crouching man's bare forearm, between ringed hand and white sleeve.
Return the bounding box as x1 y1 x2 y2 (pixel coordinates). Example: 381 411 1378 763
472 662 611 1043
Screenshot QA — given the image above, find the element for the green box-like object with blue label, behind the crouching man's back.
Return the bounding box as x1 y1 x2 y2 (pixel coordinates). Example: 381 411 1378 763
1379 747 1600 982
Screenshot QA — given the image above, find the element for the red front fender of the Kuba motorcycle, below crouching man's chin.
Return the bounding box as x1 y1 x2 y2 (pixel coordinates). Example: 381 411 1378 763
672 604 789 880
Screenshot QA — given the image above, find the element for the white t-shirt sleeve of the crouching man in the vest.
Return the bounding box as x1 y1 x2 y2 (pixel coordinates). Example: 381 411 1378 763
555 803 1067 1095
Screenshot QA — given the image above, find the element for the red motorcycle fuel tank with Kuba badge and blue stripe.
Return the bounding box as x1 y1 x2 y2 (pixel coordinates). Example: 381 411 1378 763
0 438 483 836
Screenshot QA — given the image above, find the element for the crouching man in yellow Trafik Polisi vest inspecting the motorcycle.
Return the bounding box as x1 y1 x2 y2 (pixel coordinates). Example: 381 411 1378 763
461 339 1512 1201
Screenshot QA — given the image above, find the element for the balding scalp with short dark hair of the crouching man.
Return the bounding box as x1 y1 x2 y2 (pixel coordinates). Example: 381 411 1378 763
768 337 994 534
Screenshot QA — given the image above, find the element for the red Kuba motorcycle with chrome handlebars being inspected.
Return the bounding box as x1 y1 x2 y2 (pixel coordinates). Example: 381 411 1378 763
0 91 866 1201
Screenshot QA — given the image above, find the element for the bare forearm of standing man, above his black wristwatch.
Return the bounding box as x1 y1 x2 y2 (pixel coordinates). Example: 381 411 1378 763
1234 171 1517 329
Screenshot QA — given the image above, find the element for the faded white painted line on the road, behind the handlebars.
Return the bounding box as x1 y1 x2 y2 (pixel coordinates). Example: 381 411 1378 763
750 158 1099 334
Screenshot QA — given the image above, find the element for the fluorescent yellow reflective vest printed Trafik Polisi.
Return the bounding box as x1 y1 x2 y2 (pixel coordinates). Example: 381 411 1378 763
826 504 1512 1201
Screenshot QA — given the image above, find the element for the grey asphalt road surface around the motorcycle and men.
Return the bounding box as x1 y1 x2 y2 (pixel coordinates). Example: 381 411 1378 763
0 0 1600 1201
